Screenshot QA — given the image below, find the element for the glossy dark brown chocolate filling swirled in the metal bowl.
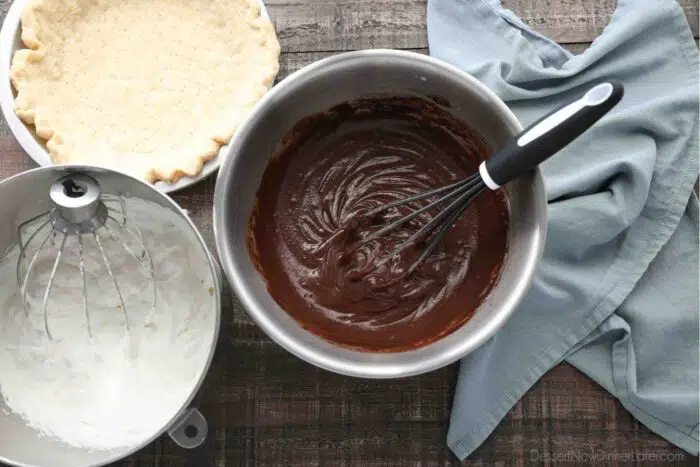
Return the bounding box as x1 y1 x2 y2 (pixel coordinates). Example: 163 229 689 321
248 97 508 352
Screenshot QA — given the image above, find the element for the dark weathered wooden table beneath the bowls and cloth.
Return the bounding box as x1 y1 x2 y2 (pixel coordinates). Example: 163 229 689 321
0 0 698 467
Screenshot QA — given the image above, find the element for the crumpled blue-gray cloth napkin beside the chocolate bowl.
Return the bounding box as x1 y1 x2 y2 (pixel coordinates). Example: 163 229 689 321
428 0 700 459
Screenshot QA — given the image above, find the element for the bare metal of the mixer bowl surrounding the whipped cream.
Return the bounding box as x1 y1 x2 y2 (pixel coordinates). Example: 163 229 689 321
0 166 221 467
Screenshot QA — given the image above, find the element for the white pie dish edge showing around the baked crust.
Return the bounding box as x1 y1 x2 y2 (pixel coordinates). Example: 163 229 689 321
0 0 269 193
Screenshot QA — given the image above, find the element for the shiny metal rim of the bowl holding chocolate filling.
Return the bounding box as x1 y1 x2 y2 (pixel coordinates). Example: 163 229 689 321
213 49 547 379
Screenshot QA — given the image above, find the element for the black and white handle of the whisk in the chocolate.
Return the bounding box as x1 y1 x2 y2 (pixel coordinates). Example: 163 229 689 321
479 81 624 190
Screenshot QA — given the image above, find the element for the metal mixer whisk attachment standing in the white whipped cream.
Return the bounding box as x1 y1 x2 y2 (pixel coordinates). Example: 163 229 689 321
17 173 156 339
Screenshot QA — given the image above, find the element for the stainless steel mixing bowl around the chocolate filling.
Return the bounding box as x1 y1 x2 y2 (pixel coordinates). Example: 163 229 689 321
214 50 547 378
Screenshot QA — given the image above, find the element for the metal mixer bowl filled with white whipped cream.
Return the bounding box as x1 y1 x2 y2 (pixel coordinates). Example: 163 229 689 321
0 166 221 467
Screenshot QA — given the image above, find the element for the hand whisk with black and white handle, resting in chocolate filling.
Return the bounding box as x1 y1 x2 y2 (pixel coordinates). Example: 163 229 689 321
361 80 624 269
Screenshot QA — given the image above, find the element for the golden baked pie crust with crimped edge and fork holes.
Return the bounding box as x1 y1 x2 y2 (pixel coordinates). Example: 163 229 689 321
10 0 280 183
